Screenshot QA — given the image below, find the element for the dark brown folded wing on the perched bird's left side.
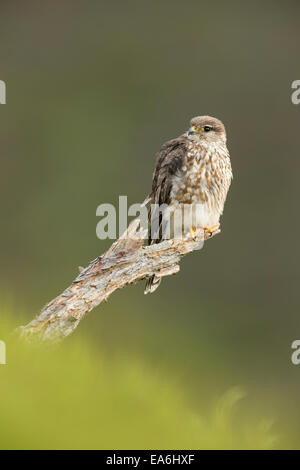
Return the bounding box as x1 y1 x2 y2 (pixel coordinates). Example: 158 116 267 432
149 134 187 245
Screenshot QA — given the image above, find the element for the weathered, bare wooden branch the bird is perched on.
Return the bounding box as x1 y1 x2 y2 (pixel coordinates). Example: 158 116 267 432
19 219 220 341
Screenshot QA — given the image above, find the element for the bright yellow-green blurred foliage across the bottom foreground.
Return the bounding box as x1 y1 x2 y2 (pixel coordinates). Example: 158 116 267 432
0 309 278 449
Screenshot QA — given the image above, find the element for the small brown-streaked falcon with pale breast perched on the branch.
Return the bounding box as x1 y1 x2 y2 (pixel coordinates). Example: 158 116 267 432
144 116 233 294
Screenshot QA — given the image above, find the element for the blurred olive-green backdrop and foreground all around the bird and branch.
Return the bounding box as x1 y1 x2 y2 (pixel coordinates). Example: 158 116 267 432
0 0 300 449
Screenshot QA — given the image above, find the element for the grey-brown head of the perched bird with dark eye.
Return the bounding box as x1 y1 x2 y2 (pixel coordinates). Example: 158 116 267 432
187 116 226 143
